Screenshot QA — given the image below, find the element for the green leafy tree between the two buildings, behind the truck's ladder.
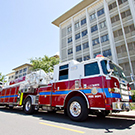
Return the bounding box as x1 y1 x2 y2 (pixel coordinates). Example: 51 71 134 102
30 55 59 73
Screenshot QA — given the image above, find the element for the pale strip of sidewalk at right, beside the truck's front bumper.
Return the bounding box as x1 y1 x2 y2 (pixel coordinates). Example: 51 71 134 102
109 110 135 118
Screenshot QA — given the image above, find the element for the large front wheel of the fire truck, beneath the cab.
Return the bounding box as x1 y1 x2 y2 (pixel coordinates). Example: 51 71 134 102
67 97 88 121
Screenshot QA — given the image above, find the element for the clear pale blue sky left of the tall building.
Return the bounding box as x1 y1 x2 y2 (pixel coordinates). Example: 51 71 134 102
0 0 81 75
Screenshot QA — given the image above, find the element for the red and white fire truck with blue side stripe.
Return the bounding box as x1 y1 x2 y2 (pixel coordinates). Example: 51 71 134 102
0 57 131 121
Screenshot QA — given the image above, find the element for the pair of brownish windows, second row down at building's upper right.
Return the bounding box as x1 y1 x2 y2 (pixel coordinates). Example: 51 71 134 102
111 9 131 23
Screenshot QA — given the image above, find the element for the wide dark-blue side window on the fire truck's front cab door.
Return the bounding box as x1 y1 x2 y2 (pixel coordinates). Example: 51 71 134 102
84 62 100 76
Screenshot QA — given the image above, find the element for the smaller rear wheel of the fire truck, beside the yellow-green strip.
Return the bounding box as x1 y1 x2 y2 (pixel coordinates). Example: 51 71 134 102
24 98 34 114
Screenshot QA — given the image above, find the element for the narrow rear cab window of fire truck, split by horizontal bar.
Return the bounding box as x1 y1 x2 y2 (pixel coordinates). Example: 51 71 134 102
59 64 68 80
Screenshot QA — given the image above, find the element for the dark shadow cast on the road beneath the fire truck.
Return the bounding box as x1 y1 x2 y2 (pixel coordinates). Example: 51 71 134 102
0 107 135 133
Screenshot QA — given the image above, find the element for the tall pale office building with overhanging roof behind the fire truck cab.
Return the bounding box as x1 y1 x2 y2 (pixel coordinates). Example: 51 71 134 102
52 0 135 80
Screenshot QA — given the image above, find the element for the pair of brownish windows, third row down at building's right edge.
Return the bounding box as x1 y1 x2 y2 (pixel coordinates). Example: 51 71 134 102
113 24 135 37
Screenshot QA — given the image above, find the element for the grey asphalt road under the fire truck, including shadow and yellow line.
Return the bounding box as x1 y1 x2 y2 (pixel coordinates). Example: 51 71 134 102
0 107 135 135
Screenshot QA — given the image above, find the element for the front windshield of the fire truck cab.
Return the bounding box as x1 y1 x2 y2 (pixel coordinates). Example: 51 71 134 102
101 60 127 80
